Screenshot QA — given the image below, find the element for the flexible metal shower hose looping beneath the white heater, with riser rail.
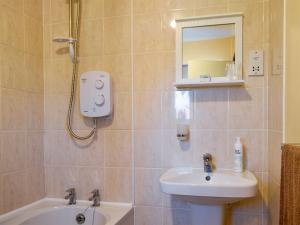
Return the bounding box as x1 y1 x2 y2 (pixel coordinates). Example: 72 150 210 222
67 0 97 140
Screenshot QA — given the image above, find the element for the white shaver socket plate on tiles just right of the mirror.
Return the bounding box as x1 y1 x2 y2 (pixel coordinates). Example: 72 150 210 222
248 50 264 76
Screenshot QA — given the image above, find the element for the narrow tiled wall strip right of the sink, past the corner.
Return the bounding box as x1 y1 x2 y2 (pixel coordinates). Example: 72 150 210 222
268 0 284 225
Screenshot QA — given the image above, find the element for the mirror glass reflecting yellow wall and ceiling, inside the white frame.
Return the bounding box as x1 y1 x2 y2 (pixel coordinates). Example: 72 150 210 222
182 24 235 81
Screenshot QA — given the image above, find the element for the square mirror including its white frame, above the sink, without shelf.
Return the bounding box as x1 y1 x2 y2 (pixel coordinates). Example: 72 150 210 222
175 14 242 86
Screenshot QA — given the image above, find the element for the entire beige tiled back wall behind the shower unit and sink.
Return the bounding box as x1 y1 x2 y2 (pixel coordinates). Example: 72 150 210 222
44 0 270 225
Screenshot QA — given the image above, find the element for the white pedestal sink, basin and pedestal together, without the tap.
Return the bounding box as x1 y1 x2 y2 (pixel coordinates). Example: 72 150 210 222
160 168 257 225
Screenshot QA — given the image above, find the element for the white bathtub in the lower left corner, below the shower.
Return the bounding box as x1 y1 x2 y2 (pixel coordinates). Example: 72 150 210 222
0 198 133 225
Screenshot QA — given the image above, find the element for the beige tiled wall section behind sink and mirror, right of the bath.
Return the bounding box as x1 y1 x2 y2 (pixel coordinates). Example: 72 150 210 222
133 0 269 225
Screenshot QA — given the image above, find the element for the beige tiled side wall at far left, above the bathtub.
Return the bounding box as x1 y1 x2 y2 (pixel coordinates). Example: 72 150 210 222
0 0 45 214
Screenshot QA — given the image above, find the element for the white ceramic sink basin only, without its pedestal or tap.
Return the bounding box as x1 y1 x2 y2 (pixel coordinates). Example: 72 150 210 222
160 168 257 205
